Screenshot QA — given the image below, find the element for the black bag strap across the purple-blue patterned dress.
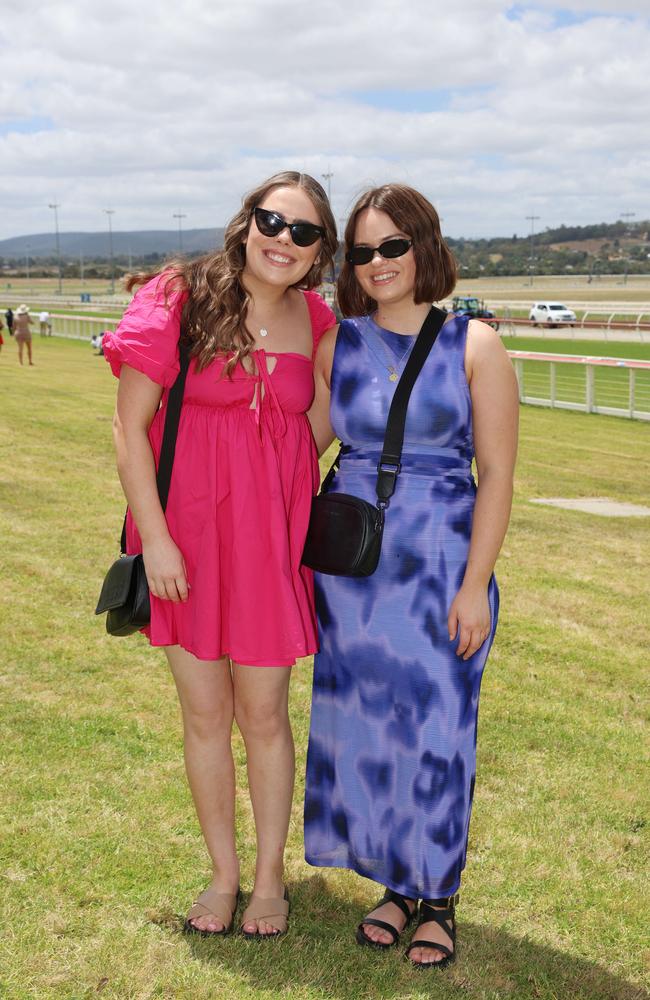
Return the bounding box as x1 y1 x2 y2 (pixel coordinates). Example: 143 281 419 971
376 306 447 507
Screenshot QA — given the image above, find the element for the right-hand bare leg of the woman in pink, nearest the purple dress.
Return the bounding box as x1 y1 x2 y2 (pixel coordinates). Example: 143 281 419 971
233 663 295 934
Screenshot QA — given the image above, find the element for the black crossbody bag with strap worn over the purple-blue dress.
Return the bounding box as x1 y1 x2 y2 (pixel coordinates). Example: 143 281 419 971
302 306 447 576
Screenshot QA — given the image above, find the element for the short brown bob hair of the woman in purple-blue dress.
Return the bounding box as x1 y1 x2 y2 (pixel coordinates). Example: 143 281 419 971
337 184 458 316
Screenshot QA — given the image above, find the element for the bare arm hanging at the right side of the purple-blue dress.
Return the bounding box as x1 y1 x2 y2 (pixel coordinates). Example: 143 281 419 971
449 321 519 659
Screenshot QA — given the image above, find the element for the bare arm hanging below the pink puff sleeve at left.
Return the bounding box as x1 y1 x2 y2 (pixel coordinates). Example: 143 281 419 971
113 365 188 601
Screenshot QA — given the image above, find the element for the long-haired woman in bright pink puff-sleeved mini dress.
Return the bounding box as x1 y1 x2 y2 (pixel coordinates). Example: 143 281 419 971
103 171 336 937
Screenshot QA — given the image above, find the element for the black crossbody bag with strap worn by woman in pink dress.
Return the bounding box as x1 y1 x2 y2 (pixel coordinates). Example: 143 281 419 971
95 344 190 635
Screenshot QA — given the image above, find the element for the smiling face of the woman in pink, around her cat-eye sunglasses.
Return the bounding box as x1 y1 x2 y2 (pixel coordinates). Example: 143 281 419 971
243 187 322 288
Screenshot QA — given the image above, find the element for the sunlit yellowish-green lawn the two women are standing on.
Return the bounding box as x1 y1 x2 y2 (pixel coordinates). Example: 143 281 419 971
0 338 650 1000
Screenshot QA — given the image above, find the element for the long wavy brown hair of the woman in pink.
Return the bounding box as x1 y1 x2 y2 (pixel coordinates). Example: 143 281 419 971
124 170 338 375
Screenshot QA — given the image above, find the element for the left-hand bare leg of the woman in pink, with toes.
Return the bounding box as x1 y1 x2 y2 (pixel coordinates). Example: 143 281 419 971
165 646 239 931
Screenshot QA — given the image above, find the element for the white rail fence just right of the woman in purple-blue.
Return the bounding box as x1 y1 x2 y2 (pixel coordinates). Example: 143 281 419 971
508 351 650 420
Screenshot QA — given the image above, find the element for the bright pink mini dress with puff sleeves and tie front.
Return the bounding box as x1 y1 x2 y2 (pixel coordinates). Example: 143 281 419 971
102 276 336 667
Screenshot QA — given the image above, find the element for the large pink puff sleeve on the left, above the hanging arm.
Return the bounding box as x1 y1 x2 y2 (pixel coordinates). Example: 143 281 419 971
102 272 187 388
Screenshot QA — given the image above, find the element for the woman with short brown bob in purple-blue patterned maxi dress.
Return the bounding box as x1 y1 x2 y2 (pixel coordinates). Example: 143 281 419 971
305 184 518 968
